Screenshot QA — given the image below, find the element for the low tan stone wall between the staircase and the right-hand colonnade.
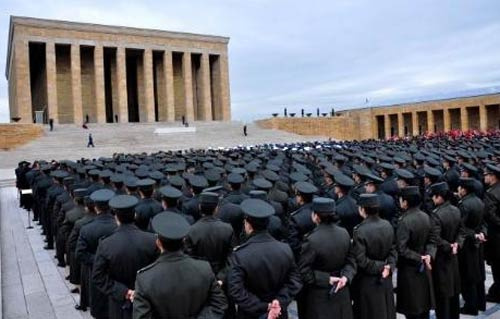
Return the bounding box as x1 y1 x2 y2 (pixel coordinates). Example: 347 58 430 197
256 116 362 140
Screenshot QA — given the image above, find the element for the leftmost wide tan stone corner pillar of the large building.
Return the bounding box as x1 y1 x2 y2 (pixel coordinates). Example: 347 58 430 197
10 40 33 123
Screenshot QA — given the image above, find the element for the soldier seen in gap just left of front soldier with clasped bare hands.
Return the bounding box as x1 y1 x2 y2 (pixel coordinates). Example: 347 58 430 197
288 182 318 259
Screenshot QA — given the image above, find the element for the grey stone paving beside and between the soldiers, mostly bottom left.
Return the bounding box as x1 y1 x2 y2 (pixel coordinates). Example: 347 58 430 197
0 187 500 319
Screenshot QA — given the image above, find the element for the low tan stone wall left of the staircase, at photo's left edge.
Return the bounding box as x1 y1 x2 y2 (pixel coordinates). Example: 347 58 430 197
0 123 43 150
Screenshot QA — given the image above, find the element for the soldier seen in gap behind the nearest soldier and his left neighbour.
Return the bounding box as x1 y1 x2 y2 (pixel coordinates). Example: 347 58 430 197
135 178 163 230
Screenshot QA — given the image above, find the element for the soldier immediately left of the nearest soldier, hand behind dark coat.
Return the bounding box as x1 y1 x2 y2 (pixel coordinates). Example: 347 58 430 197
92 195 157 319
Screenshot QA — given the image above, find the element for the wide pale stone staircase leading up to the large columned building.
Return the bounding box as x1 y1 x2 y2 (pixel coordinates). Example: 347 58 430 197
0 121 323 168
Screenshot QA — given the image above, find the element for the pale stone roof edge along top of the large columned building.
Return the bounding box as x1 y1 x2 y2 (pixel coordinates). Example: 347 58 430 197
5 16 229 79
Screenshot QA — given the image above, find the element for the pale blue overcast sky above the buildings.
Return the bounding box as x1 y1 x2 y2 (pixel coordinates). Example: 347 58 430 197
0 0 500 122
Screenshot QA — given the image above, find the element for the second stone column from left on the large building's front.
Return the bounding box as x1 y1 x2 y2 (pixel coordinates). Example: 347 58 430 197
45 42 59 123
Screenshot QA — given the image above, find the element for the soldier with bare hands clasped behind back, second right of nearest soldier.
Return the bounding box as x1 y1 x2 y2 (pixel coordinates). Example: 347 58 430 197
298 197 356 319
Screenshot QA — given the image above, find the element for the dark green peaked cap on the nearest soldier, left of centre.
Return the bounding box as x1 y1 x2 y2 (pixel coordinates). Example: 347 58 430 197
151 212 190 240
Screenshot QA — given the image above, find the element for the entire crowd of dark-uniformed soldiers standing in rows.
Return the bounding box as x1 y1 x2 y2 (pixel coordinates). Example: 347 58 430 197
16 134 500 319
